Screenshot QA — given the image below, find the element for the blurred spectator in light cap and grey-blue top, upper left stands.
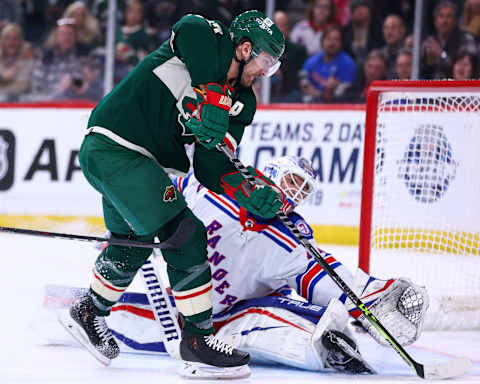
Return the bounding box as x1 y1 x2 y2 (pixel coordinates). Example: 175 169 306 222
32 19 81 100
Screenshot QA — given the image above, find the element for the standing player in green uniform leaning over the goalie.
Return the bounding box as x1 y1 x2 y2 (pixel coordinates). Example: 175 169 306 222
61 11 284 377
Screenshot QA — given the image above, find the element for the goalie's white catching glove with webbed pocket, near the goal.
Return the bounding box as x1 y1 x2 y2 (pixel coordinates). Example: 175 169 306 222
345 269 429 345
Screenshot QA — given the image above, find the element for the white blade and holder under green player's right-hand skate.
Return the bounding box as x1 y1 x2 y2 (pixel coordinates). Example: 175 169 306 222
178 361 251 380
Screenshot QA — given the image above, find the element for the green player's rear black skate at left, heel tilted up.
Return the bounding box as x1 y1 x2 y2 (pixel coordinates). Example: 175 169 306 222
59 295 120 365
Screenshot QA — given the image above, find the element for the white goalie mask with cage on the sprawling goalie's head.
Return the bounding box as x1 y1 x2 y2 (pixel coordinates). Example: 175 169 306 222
263 156 316 207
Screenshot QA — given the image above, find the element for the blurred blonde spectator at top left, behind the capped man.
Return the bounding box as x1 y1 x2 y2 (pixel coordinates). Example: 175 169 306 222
62 1 101 54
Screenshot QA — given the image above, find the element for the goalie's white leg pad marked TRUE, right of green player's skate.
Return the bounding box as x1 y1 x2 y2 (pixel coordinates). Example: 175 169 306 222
217 299 353 371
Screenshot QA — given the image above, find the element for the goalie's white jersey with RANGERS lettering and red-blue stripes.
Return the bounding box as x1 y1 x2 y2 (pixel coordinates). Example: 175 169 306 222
174 174 351 316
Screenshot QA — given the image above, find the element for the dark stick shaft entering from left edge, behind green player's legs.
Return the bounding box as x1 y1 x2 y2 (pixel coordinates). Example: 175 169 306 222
0 227 166 249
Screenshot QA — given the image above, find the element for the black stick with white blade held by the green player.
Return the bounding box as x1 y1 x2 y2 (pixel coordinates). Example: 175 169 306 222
217 143 472 379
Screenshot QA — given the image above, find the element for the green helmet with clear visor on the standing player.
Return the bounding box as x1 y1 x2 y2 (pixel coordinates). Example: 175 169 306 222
230 10 285 76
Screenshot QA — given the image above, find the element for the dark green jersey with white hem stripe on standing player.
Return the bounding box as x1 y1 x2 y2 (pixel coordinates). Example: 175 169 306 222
88 15 256 190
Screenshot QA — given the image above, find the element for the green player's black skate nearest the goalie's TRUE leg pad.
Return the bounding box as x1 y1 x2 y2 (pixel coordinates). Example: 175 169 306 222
180 328 250 378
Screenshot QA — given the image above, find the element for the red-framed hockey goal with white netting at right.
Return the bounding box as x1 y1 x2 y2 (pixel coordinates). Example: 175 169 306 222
359 80 480 330
